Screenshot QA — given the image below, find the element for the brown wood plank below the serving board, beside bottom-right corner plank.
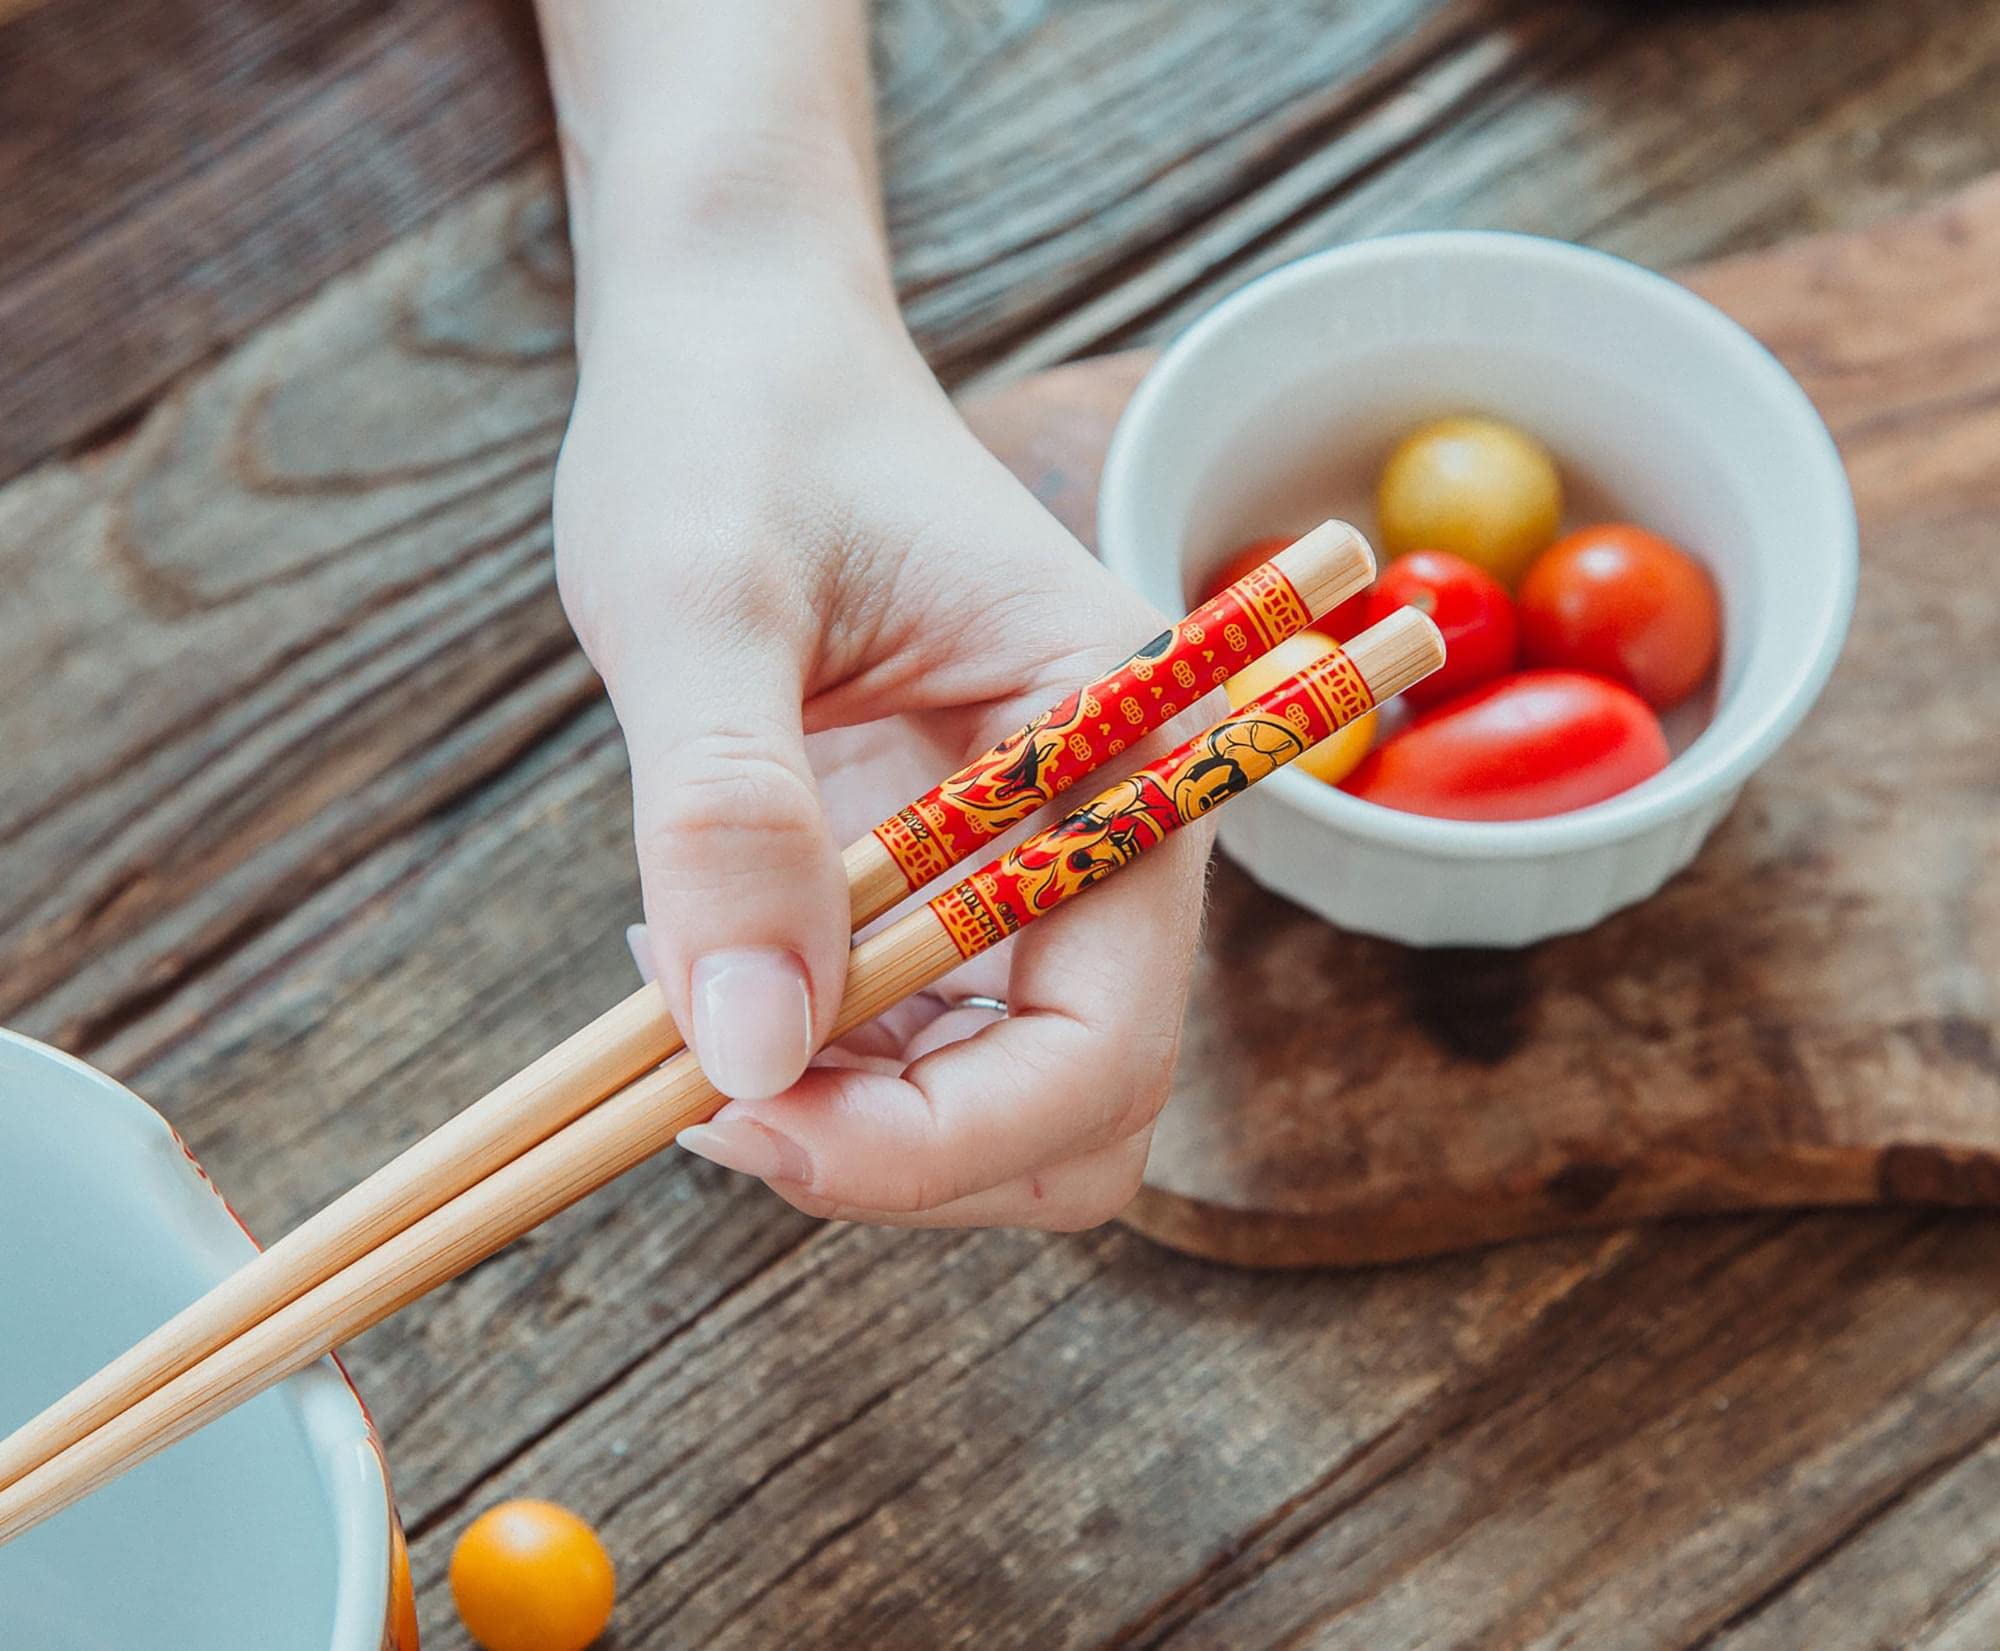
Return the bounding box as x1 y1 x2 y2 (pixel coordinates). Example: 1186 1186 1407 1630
1110 1217 2000 1651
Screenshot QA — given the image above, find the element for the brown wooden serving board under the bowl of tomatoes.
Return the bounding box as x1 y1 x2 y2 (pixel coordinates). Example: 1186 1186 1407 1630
952 180 2000 1267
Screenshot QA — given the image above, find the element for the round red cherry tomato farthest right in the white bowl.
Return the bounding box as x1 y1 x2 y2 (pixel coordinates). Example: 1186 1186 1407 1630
1520 522 1722 712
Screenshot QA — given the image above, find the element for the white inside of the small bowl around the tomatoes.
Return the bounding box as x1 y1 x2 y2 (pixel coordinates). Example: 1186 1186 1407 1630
1102 234 1854 853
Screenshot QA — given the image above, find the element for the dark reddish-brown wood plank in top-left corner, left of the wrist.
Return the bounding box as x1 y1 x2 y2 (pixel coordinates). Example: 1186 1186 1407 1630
0 0 550 478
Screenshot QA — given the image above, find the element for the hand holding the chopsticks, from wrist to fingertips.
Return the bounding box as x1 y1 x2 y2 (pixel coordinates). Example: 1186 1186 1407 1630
556 270 1206 1227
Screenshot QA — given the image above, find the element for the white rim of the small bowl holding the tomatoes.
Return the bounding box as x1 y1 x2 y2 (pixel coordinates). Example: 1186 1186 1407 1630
1098 230 1860 859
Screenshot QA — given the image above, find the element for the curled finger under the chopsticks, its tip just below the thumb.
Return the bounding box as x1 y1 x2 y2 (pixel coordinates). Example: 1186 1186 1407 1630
682 819 1204 1215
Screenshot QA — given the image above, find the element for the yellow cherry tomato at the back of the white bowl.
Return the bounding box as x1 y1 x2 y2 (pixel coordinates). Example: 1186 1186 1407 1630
1376 418 1562 588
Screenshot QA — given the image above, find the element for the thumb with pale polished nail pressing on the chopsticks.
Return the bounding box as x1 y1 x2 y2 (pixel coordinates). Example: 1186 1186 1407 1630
612 640 848 1099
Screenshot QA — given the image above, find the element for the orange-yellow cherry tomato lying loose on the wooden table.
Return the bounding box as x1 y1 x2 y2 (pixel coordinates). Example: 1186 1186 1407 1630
452 1501 616 1651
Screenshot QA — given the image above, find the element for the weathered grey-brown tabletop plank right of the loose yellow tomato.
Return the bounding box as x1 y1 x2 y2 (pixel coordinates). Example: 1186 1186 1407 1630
398 1199 1648 1647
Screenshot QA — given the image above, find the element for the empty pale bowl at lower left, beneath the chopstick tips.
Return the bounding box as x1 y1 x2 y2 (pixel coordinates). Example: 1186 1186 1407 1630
0 1031 416 1651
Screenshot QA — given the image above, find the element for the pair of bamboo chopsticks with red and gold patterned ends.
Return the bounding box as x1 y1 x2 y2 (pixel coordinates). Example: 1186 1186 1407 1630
0 522 1444 1543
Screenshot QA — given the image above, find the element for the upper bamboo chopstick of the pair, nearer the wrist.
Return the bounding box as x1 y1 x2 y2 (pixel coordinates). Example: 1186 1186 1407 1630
0 522 1374 1489
